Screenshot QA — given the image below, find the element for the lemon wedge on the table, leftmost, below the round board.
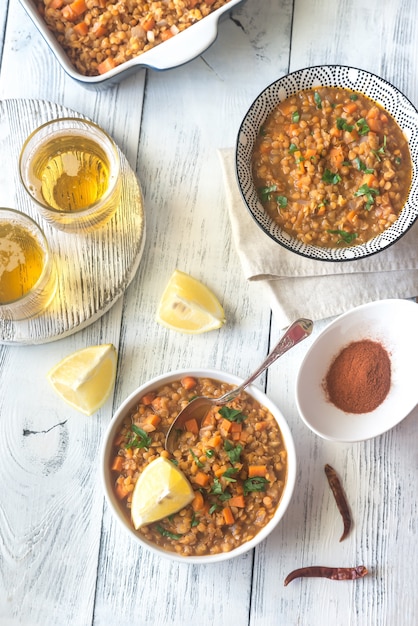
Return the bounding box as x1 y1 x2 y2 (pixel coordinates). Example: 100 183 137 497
47 343 117 415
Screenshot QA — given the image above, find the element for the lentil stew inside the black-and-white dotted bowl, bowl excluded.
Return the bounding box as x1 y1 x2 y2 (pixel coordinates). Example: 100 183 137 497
252 87 412 247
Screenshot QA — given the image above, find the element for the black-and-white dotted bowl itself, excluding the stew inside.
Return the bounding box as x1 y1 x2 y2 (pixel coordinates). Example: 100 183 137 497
235 65 418 261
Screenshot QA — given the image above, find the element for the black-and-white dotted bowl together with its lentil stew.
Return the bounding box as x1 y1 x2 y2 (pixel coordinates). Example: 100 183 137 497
236 65 418 261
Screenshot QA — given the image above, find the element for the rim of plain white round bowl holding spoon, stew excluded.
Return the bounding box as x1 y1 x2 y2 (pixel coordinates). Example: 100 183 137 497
101 369 296 564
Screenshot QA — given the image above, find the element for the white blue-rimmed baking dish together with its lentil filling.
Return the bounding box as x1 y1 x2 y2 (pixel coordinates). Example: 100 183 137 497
20 0 243 87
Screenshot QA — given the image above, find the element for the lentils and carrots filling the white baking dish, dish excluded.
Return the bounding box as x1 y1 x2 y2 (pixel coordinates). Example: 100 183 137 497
36 0 229 76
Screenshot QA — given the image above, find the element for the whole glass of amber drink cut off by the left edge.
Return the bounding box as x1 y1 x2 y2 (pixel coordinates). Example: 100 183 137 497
0 208 57 320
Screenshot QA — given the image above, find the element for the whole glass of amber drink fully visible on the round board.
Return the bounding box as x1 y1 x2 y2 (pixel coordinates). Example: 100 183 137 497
19 118 122 233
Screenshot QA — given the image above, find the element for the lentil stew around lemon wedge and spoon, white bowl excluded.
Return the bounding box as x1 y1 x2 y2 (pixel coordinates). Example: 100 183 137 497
112 377 287 557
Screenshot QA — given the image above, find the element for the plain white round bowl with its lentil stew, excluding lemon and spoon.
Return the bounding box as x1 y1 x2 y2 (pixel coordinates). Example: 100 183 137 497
101 370 296 563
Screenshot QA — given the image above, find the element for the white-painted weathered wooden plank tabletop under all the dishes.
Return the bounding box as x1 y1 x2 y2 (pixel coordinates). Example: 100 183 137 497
0 0 418 626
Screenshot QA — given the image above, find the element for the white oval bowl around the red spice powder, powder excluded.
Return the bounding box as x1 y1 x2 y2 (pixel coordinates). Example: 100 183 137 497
296 299 418 442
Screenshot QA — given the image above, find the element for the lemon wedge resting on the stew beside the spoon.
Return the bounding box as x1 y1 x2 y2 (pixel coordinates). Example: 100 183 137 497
131 456 194 529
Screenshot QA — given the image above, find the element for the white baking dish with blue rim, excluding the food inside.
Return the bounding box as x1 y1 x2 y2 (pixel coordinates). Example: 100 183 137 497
20 0 243 88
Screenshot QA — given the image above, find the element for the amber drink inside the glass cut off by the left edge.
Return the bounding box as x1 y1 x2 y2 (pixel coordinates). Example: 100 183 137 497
0 222 45 304
